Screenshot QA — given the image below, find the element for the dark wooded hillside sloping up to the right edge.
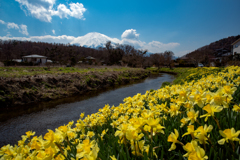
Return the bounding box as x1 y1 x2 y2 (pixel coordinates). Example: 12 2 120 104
186 35 240 57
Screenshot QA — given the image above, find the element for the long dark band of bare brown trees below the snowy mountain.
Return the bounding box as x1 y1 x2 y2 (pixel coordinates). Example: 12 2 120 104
0 40 174 68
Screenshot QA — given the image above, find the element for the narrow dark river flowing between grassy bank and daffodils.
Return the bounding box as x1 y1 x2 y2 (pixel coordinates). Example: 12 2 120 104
0 74 175 147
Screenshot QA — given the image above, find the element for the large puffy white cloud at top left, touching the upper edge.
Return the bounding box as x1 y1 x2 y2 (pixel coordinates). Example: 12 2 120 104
15 0 87 22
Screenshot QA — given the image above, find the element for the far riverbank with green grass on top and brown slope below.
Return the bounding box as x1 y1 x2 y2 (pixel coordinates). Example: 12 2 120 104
0 67 150 107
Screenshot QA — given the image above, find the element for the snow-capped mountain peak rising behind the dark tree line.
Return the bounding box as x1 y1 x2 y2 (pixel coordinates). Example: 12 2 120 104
71 32 121 48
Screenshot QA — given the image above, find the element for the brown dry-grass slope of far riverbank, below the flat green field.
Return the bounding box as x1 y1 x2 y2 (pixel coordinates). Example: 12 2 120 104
0 68 150 108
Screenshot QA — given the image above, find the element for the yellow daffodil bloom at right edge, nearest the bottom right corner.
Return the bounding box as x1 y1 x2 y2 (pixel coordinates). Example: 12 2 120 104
218 128 240 145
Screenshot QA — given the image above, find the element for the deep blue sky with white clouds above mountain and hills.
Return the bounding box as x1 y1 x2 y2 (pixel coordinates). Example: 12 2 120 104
0 0 240 56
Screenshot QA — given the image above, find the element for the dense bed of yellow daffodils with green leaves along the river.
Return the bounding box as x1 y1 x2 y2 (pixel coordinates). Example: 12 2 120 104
0 66 240 160
